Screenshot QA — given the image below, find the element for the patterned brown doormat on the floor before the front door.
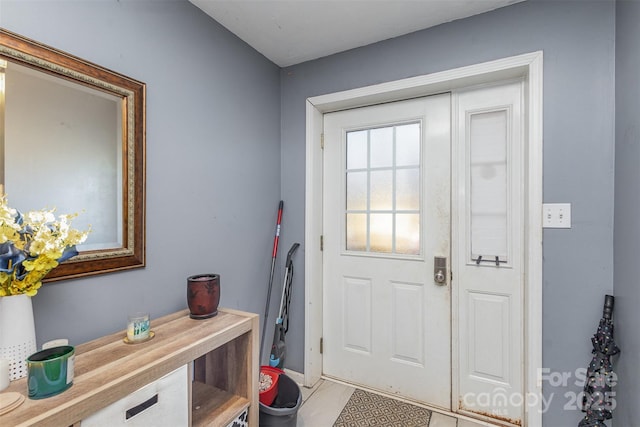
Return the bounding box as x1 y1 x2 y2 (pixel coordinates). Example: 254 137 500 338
333 389 431 427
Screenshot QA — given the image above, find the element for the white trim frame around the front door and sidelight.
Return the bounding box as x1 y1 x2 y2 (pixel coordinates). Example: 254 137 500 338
304 51 543 426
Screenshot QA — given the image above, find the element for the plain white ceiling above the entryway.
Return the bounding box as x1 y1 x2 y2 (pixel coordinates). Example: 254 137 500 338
189 0 523 67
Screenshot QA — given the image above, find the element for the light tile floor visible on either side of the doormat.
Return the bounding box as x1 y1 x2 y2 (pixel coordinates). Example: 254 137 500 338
297 379 498 427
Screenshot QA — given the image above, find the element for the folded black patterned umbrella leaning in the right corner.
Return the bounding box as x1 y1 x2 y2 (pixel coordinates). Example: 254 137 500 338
578 295 620 427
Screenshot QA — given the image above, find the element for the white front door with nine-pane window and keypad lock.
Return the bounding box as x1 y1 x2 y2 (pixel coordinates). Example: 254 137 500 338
323 94 451 409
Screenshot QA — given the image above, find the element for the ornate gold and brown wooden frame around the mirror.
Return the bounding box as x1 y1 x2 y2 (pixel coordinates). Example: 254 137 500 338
0 28 146 281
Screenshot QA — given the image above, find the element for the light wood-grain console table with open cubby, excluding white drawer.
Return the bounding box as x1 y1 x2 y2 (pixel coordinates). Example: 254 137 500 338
0 309 259 427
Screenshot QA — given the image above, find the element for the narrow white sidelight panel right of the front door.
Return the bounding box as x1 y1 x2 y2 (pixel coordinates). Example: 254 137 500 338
452 81 527 425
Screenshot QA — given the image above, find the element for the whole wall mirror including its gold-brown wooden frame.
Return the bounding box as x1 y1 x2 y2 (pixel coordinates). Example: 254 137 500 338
0 28 146 281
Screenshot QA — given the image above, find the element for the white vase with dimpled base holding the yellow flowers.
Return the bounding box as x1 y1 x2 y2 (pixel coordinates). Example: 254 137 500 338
0 295 36 381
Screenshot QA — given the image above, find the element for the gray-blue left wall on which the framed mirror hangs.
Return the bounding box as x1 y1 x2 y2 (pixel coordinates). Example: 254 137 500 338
0 0 280 352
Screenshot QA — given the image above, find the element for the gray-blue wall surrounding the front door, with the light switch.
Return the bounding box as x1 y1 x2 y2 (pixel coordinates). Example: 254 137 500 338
281 1 615 427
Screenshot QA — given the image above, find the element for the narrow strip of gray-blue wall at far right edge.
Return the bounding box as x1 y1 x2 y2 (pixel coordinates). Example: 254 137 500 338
613 0 640 426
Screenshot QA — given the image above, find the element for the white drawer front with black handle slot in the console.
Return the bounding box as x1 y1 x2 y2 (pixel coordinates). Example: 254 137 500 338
81 365 189 427
